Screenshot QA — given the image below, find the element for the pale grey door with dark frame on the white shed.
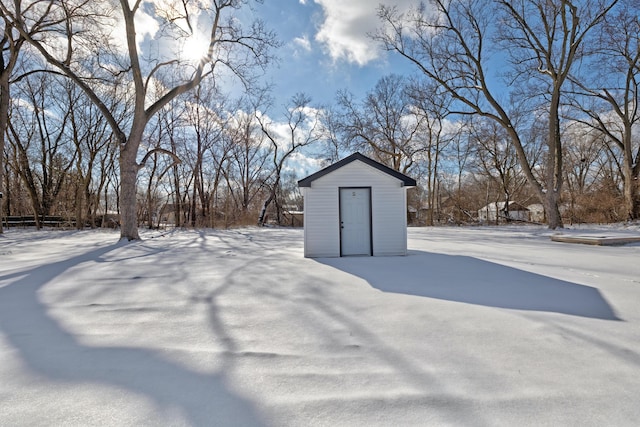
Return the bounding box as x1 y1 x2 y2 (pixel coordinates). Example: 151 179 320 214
340 188 371 256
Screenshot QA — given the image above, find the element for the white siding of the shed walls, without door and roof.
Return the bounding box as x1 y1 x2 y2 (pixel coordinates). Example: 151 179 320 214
304 161 407 257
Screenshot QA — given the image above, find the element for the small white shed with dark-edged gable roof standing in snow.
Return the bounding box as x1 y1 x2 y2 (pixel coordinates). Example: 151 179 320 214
298 153 416 257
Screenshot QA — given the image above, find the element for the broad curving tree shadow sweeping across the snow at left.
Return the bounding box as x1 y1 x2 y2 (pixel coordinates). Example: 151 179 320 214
0 244 263 426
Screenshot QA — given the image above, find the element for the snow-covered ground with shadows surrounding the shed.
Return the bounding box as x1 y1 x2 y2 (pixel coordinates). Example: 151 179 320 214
0 225 640 426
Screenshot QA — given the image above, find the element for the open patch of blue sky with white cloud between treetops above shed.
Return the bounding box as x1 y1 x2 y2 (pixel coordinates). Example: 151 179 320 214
255 0 416 112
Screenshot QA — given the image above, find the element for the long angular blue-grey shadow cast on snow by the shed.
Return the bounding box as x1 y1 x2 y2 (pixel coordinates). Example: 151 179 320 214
317 251 621 320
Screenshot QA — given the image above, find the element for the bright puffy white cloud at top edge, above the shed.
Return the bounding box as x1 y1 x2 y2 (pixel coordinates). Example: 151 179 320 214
314 0 416 66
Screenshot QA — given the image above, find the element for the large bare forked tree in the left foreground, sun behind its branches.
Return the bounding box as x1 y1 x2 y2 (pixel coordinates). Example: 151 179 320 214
0 0 277 240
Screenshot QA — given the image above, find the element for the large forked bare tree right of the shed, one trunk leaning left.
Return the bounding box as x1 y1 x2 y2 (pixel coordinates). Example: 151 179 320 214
377 0 617 228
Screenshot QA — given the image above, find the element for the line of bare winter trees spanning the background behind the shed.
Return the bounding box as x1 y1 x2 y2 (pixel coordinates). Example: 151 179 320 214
0 0 640 239
